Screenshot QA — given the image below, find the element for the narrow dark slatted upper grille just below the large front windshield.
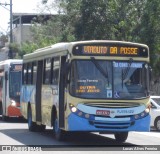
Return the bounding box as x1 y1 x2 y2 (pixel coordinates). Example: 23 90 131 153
84 102 140 108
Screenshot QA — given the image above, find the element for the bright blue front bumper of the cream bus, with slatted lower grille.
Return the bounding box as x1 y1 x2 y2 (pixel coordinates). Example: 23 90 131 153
68 113 150 132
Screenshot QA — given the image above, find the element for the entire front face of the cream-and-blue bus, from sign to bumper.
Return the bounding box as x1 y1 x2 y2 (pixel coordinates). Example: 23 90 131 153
67 42 150 138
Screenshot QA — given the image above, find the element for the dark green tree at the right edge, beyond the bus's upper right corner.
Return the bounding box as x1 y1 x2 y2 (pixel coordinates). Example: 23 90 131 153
140 0 160 72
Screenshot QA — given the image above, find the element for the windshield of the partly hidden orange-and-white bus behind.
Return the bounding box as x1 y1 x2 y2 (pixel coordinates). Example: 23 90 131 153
9 64 22 101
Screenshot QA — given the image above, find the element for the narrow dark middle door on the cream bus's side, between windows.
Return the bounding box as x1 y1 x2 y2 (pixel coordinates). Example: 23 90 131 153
35 61 43 122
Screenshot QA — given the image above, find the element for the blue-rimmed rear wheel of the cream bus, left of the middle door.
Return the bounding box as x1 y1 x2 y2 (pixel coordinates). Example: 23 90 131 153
27 106 37 132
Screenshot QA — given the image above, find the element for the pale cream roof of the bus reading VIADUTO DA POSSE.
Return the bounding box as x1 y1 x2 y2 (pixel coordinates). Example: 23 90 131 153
23 40 148 62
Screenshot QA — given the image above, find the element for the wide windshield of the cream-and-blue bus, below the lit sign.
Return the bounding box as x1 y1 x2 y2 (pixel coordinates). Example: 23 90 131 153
70 59 148 99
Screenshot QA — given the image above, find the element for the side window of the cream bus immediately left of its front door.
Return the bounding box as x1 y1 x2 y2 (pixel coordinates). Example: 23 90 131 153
52 57 60 85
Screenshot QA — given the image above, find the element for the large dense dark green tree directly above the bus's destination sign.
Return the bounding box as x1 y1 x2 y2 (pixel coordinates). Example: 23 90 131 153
70 0 146 41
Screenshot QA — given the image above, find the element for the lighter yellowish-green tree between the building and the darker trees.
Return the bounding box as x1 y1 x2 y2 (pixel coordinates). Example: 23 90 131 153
17 0 75 57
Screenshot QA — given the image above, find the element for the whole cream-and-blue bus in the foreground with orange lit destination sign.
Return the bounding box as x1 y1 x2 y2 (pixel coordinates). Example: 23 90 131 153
21 40 150 142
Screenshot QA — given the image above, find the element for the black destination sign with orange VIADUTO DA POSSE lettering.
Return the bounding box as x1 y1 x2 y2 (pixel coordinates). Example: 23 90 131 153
73 45 148 57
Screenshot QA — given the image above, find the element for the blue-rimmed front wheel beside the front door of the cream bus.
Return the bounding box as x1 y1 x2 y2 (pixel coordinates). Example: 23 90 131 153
53 118 64 141
